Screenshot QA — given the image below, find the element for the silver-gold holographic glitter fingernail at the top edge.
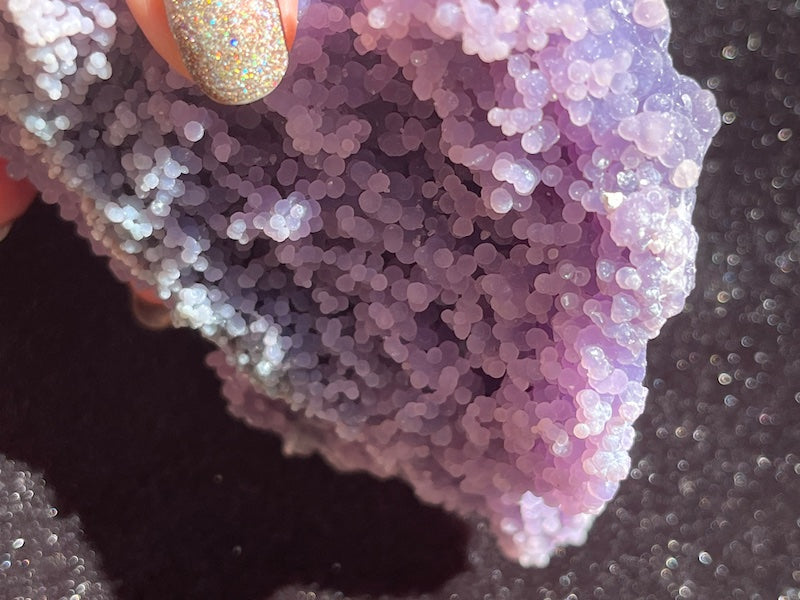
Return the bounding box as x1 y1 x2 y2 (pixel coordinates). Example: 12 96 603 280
164 0 289 104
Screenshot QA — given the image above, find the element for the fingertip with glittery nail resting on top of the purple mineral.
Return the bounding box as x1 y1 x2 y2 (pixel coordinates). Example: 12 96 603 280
128 0 297 104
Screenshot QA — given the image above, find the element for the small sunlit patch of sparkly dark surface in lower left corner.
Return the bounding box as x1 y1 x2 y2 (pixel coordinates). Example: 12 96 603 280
0 455 113 600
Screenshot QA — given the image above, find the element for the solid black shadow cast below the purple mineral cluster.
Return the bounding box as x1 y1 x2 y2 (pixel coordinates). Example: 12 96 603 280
0 204 467 600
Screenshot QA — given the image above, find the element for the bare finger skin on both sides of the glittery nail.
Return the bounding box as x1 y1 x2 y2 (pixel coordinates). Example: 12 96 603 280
128 0 297 79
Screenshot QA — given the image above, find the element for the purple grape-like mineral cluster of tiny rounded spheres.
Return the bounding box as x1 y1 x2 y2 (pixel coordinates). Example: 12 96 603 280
0 0 720 565
